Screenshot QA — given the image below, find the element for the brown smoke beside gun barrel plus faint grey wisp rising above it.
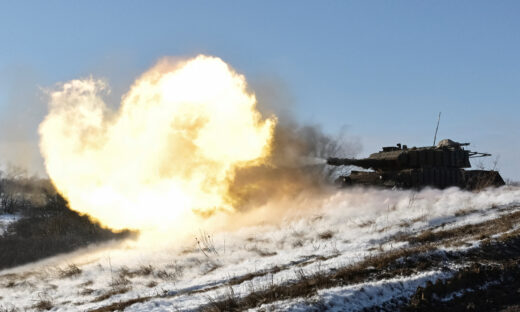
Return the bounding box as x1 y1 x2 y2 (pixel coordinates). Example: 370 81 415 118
229 76 361 211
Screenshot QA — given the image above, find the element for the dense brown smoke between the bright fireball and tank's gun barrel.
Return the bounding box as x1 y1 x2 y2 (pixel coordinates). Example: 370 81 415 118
229 120 359 211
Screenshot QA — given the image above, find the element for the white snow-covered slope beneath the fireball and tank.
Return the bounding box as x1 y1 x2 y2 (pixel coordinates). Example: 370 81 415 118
0 187 520 311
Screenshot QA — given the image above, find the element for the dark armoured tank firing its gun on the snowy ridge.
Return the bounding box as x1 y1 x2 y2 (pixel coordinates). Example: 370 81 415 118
327 139 505 190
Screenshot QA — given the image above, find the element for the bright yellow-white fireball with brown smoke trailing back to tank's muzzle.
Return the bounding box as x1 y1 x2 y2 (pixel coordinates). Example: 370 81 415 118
39 55 358 231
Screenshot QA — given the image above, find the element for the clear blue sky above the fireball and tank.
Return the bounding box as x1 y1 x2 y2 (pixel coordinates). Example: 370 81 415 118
0 1 520 180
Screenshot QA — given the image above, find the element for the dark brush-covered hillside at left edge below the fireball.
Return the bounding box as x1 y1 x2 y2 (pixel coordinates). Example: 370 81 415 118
0 176 134 269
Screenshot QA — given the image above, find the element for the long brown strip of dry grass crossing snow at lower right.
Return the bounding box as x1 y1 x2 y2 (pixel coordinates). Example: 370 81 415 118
203 208 520 312
